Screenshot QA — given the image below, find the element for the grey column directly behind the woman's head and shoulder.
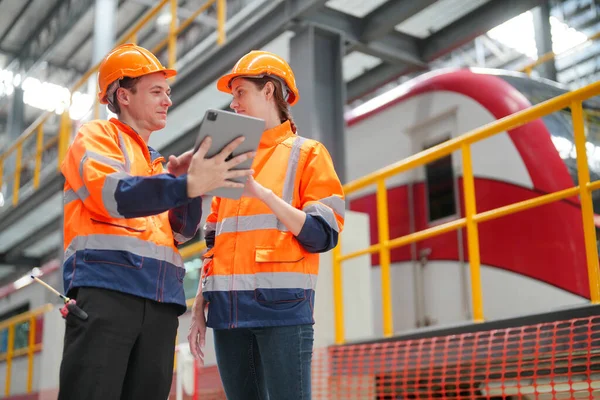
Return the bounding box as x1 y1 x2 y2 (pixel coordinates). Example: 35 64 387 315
290 25 346 183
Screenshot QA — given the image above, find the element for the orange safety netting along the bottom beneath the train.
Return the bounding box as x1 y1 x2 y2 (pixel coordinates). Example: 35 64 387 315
189 317 600 400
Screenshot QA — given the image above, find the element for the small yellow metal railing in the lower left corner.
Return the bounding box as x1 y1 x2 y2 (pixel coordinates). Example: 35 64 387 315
0 304 54 396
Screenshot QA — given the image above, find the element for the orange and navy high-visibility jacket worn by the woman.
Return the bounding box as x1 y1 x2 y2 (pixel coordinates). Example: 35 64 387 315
202 121 345 329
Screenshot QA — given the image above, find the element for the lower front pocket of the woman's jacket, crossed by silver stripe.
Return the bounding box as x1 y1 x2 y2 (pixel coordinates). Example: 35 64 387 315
254 246 306 308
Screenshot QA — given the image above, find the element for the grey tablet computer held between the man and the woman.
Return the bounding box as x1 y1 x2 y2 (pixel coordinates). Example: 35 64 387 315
194 108 265 200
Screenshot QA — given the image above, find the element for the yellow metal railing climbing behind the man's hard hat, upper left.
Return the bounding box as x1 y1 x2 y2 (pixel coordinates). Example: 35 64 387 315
0 0 226 211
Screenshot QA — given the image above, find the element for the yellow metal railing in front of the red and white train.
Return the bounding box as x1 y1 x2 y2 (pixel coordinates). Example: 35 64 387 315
333 82 600 344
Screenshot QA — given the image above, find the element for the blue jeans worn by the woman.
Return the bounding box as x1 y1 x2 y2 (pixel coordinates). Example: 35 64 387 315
214 325 314 400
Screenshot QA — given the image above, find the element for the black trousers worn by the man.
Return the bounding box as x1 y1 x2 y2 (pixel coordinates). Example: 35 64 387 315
58 287 179 400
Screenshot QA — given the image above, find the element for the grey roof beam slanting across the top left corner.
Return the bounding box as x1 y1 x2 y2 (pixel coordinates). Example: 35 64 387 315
8 0 94 76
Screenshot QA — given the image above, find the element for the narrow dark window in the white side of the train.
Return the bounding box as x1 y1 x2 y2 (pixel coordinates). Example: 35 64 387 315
425 137 456 222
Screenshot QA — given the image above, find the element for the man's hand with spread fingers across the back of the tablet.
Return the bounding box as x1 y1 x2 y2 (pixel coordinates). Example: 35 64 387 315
187 136 255 198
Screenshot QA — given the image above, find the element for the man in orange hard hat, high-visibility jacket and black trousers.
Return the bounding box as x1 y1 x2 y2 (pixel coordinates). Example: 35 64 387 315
59 44 252 400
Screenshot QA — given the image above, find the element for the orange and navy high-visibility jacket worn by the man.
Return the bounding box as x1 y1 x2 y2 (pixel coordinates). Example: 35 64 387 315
61 119 202 313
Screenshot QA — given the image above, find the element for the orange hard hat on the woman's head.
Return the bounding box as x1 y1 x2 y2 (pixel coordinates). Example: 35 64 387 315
217 50 300 106
